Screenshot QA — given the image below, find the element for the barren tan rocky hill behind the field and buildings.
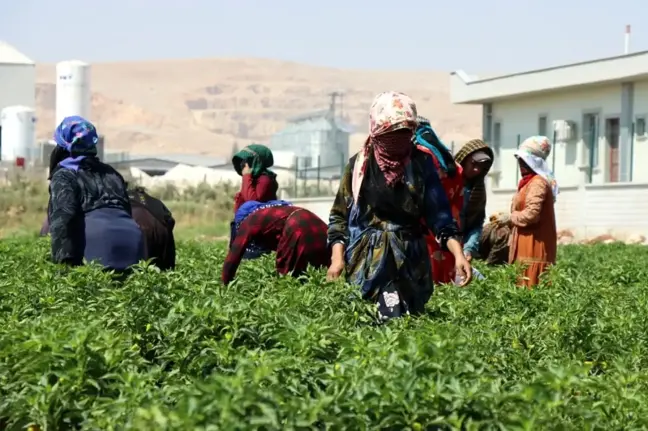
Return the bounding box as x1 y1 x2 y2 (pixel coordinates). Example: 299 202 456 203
36 59 480 156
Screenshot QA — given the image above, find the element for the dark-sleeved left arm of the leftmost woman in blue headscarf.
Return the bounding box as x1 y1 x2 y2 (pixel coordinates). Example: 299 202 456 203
49 169 83 265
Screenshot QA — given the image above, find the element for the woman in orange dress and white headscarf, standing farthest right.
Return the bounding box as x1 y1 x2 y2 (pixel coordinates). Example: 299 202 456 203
500 136 558 288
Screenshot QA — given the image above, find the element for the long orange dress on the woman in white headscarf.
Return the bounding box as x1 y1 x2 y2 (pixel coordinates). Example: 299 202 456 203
509 175 558 288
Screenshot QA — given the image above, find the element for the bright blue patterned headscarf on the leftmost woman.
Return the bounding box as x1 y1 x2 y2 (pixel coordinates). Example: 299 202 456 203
54 115 99 171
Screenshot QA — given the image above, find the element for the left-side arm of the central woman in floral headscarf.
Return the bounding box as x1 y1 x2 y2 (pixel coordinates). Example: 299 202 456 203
328 163 353 260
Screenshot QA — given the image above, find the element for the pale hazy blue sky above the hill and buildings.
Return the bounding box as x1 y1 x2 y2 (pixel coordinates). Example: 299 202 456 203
0 0 648 73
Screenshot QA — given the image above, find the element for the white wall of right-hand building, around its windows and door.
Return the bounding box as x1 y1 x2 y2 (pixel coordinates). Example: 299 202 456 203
492 81 648 189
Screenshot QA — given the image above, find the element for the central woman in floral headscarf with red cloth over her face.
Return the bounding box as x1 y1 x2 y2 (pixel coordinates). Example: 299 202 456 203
328 92 471 320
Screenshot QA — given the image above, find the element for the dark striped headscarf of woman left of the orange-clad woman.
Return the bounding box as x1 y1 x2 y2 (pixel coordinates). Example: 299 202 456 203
455 139 495 229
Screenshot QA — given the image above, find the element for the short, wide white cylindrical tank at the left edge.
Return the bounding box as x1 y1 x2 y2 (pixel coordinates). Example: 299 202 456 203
0 106 36 162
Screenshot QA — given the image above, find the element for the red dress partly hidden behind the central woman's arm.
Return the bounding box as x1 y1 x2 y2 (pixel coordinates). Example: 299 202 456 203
416 145 464 284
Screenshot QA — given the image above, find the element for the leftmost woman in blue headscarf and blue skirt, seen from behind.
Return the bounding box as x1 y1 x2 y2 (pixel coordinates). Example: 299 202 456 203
48 116 144 271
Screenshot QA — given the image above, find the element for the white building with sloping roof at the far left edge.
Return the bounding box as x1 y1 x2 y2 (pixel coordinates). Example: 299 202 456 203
0 41 36 115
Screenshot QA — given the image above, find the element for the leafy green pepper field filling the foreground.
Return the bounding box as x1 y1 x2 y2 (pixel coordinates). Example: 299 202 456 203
0 239 648 430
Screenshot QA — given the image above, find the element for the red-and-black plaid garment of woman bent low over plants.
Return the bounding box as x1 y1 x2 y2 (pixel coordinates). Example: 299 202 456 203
221 201 330 285
